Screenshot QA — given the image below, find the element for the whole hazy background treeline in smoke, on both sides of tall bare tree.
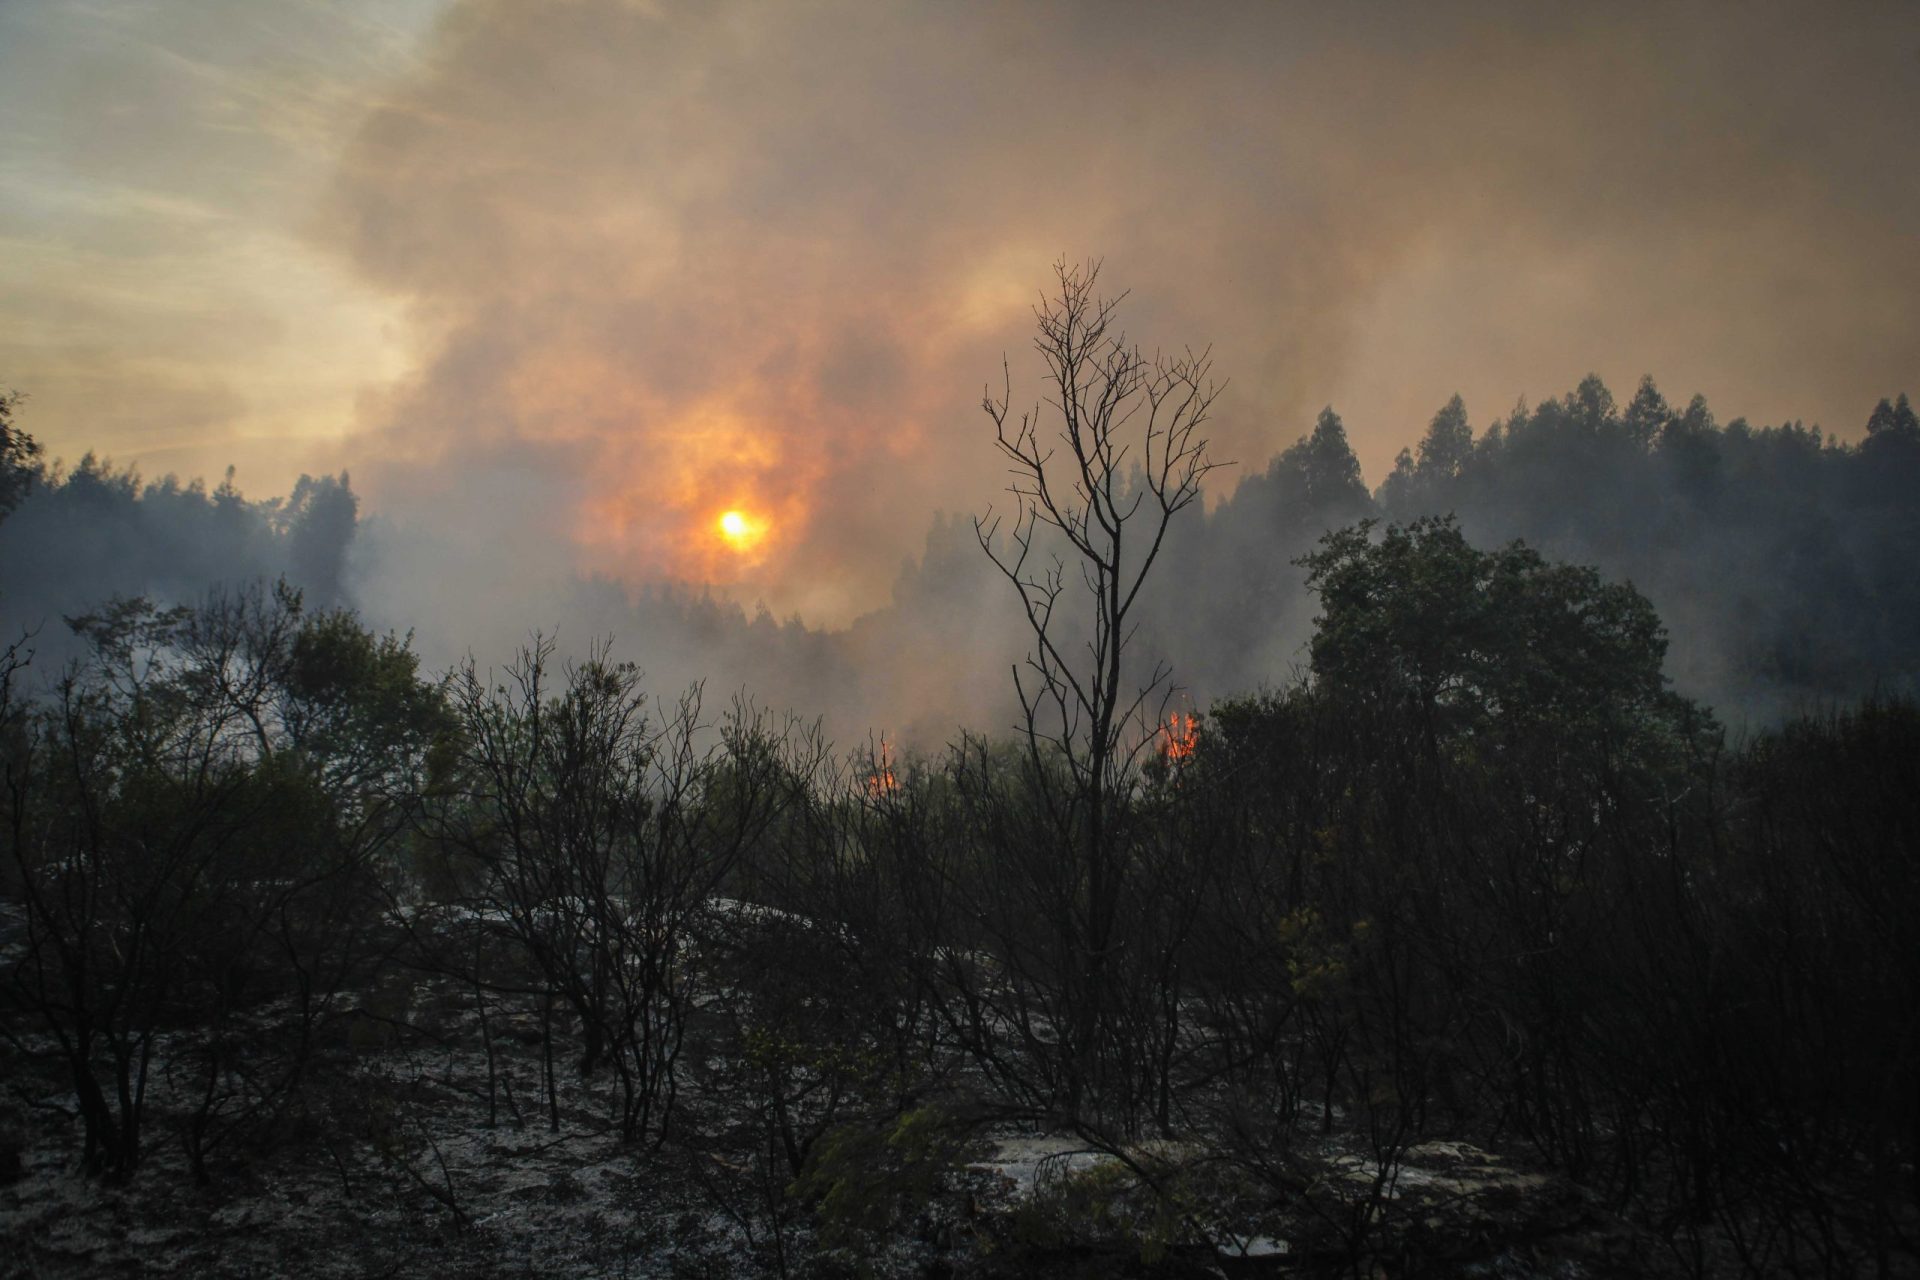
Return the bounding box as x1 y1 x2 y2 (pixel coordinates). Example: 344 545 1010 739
0 378 1920 745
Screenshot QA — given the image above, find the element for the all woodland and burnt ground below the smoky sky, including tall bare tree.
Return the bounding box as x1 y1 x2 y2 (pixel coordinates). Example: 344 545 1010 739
0 347 1920 1276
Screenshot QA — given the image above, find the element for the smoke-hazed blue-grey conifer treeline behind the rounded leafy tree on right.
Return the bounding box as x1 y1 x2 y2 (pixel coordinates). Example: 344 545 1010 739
1154 376 1920 722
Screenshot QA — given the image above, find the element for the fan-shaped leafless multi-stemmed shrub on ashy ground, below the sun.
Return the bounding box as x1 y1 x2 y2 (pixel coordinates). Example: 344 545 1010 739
426 635 824 1142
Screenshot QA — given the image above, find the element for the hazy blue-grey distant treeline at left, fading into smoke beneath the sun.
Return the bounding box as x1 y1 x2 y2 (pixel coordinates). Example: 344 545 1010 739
0 408 879 729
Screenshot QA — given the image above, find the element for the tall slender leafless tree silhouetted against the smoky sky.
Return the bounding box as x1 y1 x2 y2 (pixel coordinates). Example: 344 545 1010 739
973 261 1219 1115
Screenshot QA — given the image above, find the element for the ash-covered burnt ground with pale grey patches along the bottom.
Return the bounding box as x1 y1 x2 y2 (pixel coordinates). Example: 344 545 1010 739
0 909 1715 1278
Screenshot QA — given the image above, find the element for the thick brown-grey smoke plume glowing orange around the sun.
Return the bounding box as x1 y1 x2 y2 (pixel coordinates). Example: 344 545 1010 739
3 0 1920 735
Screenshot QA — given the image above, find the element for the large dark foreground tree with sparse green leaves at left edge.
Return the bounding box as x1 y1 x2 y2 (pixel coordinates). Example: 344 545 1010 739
0 585 445 1178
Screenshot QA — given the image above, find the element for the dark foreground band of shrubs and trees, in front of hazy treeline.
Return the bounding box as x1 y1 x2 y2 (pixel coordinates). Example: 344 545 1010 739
0 520 1920 1274
